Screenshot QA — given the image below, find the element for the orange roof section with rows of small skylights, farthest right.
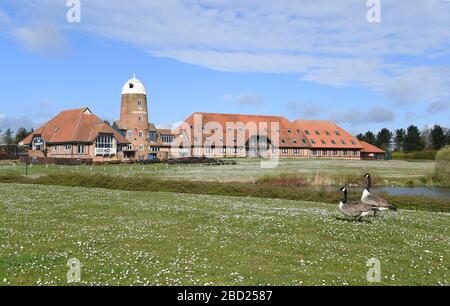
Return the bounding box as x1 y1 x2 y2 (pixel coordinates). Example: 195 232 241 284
294 120 362 149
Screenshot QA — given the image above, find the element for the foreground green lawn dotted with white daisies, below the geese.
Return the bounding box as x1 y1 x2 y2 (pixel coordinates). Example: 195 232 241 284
0 184 450 285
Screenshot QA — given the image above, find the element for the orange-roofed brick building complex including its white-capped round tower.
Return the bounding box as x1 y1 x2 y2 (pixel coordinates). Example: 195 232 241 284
23 76 385 162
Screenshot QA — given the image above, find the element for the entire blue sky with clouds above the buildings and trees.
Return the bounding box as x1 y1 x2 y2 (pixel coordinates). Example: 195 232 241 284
0 0 450 133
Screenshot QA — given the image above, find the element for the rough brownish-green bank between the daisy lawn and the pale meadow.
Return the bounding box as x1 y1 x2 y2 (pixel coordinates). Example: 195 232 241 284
0 174 450 212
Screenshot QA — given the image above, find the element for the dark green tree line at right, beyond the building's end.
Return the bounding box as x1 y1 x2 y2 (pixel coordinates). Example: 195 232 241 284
356 125 450 152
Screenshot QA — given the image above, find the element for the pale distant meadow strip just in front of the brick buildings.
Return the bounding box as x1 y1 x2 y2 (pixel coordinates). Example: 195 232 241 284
0 159 435 185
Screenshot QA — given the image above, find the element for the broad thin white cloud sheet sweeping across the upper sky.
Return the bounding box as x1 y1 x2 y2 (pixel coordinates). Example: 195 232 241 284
4 0 450 103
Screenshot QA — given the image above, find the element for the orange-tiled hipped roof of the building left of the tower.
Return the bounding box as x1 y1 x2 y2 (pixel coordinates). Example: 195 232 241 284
23 107 129 145
